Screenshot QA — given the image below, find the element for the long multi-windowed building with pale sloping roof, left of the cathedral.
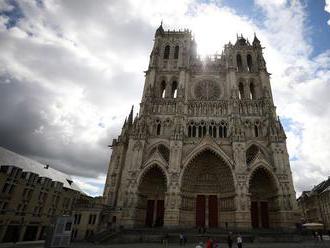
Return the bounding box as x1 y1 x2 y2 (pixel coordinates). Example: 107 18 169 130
0 147 81 242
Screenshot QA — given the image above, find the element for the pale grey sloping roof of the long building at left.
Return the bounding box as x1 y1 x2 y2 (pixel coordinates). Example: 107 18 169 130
0 147 81 192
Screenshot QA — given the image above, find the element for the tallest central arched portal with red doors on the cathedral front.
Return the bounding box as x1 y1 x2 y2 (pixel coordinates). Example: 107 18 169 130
180 149 235 228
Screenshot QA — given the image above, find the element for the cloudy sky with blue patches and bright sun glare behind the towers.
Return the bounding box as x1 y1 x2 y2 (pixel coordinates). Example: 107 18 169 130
0 0 330 195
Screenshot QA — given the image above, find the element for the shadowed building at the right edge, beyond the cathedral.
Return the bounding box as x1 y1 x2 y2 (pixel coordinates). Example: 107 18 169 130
297 177 330 230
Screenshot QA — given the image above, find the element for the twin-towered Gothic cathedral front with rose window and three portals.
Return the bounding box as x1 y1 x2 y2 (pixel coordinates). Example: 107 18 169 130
104 25 297 228
